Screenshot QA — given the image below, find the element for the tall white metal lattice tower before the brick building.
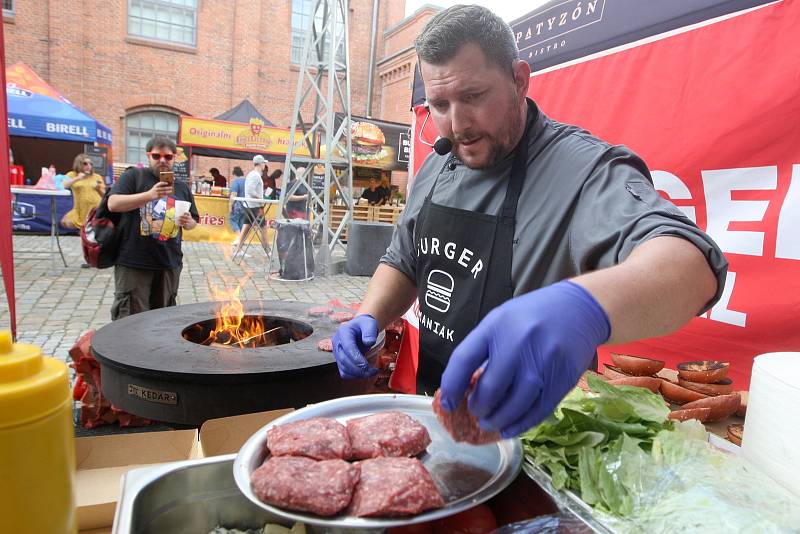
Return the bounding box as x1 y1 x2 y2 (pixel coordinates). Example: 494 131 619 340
271 0 353 276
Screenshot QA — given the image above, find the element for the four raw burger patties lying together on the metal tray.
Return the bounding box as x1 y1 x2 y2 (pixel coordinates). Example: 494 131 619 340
251 412 445 517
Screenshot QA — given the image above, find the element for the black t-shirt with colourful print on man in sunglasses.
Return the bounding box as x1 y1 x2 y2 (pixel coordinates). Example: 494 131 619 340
111 168 200 271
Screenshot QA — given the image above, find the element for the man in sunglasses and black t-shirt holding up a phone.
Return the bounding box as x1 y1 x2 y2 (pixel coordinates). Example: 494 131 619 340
108 136 200 321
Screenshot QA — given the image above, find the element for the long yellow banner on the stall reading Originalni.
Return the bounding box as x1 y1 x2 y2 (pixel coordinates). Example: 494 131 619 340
178 117 311 156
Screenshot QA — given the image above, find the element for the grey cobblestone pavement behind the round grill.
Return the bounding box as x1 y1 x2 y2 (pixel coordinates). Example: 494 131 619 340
0 235 369 372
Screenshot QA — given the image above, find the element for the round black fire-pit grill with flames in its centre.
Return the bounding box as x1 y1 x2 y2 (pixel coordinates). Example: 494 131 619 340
92 301 384 425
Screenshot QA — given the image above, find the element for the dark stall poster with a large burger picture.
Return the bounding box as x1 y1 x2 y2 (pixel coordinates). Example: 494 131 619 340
335 113 411 171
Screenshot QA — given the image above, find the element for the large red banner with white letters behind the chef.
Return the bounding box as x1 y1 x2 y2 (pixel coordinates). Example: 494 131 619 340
414 1 800 389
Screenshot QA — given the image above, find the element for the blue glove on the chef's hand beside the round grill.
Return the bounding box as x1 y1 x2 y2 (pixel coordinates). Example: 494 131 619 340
332 314 378 379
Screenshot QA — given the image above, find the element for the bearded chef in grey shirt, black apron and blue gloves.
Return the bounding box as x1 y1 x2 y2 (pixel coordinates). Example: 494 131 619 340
333 5 727 437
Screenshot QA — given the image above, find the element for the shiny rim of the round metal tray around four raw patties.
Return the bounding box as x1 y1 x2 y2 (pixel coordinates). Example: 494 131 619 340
233 394 522 529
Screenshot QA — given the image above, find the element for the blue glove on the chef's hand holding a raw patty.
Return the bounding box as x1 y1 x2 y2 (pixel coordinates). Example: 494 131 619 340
441 281 611 438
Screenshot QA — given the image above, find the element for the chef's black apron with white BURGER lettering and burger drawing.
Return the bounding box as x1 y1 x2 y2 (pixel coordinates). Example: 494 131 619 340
414 104 538 395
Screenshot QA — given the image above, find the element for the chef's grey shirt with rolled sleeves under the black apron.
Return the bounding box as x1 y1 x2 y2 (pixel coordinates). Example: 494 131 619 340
381 102 728 311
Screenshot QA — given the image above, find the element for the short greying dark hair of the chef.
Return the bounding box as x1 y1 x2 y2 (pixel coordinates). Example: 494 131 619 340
414 5 519 78
